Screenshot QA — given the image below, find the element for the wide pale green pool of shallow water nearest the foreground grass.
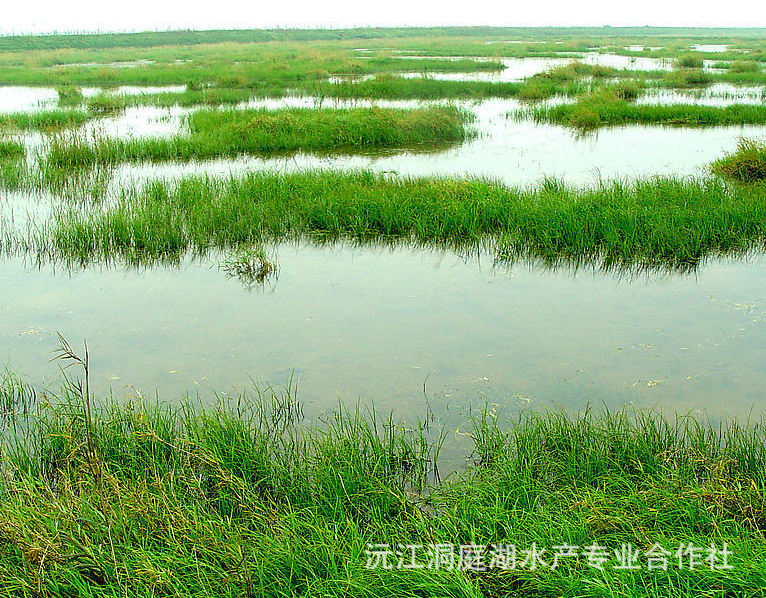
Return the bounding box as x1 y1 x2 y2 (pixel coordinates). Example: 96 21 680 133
0 245 766 421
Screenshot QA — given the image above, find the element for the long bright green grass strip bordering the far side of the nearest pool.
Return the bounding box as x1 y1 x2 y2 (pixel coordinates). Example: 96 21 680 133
25 171 766 267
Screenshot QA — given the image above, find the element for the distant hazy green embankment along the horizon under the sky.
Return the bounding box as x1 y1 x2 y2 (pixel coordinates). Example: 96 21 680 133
0 27 766 51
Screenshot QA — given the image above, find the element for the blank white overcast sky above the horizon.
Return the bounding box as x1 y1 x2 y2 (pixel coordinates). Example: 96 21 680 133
0 0 766 33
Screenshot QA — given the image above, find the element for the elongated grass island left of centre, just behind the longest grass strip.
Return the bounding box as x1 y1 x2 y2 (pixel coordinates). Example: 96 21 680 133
43 106 471 169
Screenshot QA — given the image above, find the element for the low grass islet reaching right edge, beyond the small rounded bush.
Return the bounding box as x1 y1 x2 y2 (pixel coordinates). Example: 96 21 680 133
532 98 766 130
